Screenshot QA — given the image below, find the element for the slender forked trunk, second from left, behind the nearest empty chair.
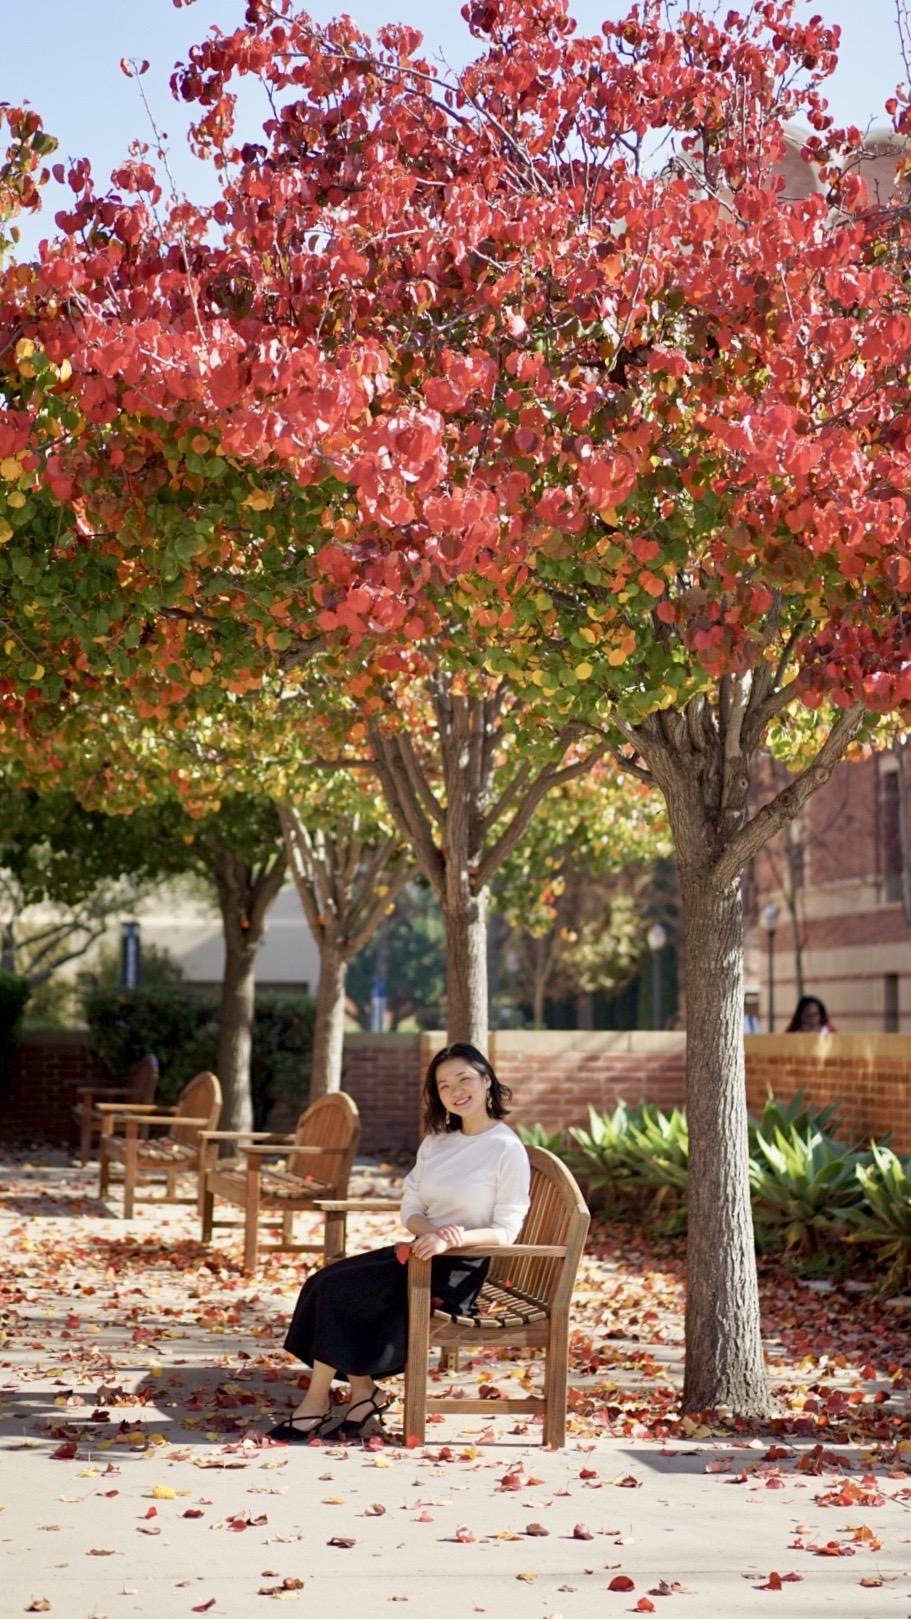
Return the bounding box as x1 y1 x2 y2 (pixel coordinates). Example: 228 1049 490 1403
278 805 414 1101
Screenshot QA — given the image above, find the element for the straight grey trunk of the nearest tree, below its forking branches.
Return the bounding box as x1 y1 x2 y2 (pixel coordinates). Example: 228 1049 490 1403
681 869 770 1417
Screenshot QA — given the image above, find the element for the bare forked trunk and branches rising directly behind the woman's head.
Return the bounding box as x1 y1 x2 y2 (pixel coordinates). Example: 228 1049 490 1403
371 674 607 1051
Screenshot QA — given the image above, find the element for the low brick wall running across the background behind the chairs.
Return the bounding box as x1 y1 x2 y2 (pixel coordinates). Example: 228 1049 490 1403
7 1030 911 1156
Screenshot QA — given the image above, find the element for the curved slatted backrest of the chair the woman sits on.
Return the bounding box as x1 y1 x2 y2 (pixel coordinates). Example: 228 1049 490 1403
489 1146 591 1307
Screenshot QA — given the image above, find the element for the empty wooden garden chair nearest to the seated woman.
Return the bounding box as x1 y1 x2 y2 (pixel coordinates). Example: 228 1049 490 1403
199 1091 361 1274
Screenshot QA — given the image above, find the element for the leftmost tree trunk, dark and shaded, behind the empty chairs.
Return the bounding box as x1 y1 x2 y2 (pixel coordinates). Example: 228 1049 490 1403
212 845 288 1130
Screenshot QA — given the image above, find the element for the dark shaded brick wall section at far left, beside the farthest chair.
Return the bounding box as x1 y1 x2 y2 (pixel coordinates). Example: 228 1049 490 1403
0 1030 112 1143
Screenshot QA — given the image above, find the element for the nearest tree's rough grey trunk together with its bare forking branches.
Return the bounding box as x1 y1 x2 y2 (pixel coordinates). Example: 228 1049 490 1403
623 665 862 1417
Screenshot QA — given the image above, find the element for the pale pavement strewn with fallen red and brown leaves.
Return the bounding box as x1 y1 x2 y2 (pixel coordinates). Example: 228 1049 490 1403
0 1162 911 1619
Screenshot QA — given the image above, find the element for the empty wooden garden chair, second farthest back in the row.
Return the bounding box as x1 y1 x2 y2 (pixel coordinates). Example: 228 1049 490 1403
99 1073 222 1219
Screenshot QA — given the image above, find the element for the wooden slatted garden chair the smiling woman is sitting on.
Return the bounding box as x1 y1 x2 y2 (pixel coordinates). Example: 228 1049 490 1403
405 1146 589 1446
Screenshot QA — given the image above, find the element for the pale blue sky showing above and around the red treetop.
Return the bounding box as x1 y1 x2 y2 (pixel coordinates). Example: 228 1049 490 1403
0 0 903 249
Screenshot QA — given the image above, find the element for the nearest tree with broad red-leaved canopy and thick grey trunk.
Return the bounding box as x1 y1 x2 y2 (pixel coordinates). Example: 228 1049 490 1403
0 0 911 1413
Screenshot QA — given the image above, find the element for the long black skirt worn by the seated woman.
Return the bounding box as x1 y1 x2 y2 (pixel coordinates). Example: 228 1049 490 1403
285 1248 490 1378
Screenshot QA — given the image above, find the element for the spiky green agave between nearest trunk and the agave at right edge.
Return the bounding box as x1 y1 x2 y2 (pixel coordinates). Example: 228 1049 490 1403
749 1125 862 1255
